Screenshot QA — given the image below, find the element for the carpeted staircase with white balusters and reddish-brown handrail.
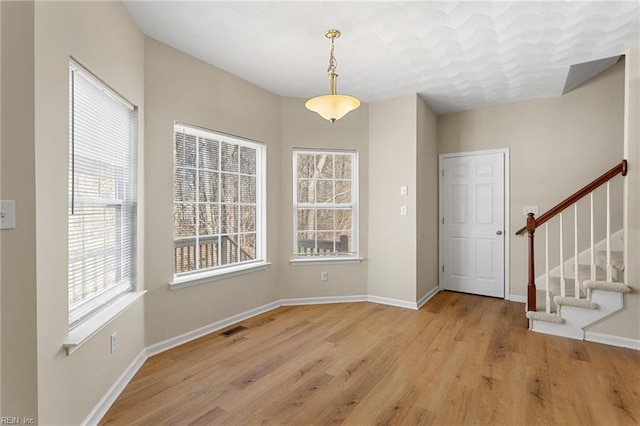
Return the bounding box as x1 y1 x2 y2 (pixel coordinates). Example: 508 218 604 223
516 160 631 340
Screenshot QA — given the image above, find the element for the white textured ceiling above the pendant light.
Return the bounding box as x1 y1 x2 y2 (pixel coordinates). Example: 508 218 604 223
125 0 640 113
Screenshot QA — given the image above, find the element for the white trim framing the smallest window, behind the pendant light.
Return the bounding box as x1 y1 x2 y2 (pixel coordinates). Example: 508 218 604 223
289 147 364 265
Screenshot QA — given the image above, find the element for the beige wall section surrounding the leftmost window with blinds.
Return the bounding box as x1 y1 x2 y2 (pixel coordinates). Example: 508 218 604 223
33 2 145 424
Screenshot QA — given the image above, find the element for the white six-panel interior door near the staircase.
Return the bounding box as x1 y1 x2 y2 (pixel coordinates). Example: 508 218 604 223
440 152 505 297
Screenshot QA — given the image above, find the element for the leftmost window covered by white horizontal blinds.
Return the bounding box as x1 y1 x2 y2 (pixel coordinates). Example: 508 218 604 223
68 62 137 329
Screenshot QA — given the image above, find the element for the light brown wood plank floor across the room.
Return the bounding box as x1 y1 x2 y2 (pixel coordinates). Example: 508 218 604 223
101 292 640 425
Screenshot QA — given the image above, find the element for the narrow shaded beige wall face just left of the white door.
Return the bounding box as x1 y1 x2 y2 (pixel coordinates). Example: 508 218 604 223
412 96 438 301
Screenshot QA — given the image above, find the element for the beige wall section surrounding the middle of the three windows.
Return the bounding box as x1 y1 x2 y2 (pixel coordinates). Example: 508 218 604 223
145 38 280 345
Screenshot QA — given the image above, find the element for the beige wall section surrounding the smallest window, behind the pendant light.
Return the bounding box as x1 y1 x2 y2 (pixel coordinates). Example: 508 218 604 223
279 98 369 299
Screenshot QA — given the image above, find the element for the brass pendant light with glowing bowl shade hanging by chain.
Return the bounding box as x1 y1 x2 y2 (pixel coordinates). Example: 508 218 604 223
304 30 360 123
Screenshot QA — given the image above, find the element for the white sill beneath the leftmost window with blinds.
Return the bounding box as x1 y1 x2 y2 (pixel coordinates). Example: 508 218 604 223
62 290 147 356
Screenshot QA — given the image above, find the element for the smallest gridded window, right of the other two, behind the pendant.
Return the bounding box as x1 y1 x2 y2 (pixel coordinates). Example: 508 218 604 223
293 150 358 258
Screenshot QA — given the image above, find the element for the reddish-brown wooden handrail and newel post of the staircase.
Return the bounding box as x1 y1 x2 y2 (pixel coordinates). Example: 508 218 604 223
516 160 627 311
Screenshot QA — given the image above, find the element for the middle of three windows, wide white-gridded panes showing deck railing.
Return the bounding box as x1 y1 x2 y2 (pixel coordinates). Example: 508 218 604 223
173 125 265 277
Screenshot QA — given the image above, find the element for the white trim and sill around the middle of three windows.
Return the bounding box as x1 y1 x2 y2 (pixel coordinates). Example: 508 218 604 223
169 121 271 282
